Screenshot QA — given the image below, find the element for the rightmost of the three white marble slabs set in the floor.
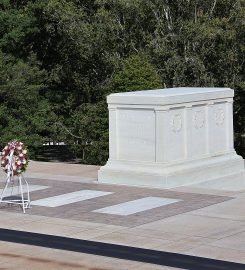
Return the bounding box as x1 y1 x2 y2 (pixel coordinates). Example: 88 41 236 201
93 197 180 216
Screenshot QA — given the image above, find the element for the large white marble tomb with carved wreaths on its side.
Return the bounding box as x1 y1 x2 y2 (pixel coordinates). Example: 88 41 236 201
98 88 244 188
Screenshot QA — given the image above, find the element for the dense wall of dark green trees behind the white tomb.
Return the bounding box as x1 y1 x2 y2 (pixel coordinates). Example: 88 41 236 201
0 0 245 164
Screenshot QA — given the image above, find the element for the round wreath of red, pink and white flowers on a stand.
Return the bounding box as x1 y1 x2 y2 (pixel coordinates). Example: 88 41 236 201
0 141 29 175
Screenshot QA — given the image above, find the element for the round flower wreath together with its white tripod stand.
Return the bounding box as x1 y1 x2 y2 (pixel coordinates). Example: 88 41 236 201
0 141 31 213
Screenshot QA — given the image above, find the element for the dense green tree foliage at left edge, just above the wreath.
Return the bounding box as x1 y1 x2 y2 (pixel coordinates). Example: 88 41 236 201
0 50 50 156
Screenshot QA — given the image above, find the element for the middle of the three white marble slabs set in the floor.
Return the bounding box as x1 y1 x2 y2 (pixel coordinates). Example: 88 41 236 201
31 190 113 207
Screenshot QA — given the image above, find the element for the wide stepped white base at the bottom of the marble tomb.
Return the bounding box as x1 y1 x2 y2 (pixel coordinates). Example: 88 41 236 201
98 152 245 190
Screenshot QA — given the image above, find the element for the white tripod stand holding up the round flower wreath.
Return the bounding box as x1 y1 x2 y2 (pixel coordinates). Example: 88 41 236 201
0 150 31 213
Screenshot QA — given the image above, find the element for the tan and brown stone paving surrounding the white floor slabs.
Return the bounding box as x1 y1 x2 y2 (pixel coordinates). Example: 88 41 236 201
0 162 245 270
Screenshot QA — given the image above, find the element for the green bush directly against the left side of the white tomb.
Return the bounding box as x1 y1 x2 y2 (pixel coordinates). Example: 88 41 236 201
63 101 109 164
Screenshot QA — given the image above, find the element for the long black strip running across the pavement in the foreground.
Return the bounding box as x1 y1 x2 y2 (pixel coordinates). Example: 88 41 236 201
0 229 245 270
